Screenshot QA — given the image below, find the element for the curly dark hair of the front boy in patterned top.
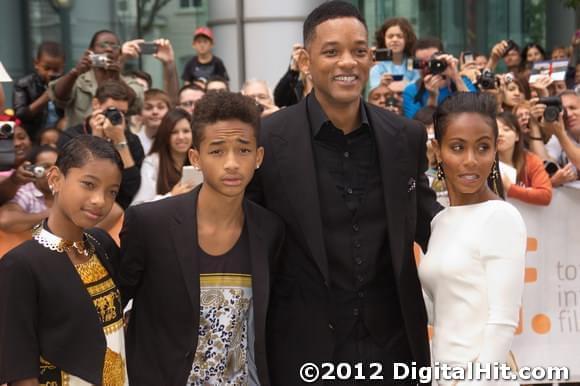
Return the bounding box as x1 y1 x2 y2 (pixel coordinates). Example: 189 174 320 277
192 91 260 149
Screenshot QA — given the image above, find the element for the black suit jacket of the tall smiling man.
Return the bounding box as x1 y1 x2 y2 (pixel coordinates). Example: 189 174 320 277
249 94 440 385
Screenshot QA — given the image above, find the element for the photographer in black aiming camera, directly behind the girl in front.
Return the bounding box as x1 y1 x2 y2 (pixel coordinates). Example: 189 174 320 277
57 80 145 211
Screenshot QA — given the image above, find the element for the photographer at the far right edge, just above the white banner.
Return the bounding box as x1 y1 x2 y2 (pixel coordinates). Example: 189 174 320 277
544 91 580 184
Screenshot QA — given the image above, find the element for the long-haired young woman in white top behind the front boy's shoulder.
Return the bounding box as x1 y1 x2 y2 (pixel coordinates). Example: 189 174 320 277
133 109 193 205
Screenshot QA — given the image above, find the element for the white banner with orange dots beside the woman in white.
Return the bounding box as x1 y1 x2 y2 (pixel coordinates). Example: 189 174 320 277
510 188 580 381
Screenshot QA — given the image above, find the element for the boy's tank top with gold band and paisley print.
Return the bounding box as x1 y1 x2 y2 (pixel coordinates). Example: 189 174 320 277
188 226 259 386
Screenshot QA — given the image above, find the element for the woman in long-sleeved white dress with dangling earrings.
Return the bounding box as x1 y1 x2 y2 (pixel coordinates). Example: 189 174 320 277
419 93 526 385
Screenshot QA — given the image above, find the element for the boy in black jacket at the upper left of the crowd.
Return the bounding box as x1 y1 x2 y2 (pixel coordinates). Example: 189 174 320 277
13 42 64 140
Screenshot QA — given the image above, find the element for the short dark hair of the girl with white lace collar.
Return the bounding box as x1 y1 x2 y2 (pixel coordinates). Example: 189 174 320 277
56 135 123 175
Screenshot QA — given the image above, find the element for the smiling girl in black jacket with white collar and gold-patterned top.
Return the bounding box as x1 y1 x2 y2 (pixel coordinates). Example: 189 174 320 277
0 136 128 386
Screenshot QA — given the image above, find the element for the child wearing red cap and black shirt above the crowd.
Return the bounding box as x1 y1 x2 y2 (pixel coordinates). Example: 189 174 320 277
181 27 229 84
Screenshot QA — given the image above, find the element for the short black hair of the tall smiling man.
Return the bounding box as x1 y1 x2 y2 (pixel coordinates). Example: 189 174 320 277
302 0 368 47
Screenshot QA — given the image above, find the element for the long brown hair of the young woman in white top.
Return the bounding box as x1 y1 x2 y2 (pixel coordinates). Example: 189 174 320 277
149 108 191 194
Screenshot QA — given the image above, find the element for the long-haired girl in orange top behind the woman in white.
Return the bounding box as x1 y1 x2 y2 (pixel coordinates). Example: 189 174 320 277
497 112 552 205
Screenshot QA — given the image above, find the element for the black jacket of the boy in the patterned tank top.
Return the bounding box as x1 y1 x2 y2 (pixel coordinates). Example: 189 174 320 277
117 187 284 386
